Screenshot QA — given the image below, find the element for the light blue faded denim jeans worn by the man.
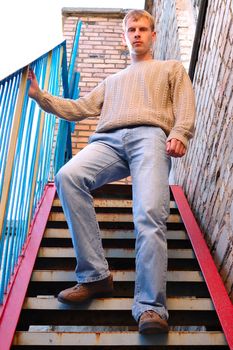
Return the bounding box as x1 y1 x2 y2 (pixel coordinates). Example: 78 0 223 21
55 126 170 321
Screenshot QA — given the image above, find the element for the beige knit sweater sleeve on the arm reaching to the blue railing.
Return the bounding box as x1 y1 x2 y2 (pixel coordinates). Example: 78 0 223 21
35 82 104 121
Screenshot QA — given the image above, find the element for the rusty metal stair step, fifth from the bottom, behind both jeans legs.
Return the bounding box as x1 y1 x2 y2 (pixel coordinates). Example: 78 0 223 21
44 228 189 241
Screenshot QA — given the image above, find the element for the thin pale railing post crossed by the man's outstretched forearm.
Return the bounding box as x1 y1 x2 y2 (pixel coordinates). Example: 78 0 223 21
27 51 52 232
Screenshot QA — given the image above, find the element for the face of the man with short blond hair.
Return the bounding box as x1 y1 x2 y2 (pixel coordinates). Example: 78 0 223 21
124 17 155 60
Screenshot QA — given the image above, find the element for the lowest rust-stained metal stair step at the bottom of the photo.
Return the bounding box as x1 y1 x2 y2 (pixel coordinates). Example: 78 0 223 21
13 331 227 350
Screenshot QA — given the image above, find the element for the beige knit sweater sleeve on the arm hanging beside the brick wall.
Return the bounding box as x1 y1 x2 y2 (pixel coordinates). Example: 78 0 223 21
167 62 195 147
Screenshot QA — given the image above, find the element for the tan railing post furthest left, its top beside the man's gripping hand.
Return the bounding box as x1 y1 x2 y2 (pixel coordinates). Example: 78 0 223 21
0 66 28 240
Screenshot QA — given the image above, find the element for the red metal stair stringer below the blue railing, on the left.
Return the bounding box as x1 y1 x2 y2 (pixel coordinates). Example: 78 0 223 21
0 183 56 350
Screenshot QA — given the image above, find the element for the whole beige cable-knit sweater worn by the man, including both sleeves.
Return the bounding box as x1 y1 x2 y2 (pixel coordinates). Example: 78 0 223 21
36 60 195 146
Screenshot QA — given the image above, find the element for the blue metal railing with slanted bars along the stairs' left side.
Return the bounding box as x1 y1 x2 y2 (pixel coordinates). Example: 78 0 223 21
0 23 81 304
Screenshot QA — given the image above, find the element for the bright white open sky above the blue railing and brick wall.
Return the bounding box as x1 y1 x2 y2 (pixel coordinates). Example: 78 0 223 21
0 0 145 80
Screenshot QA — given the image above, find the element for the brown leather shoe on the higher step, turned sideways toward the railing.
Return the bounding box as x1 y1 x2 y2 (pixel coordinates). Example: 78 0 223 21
57 275 113 304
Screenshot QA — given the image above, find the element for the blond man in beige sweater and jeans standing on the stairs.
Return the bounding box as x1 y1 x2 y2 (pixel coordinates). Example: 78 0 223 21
29 10 195 334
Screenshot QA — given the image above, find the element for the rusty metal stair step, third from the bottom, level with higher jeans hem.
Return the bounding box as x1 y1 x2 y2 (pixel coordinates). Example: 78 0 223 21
31 270 204 283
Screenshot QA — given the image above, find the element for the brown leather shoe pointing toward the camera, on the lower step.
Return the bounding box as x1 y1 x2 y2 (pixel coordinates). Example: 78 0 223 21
138 310 169 334
